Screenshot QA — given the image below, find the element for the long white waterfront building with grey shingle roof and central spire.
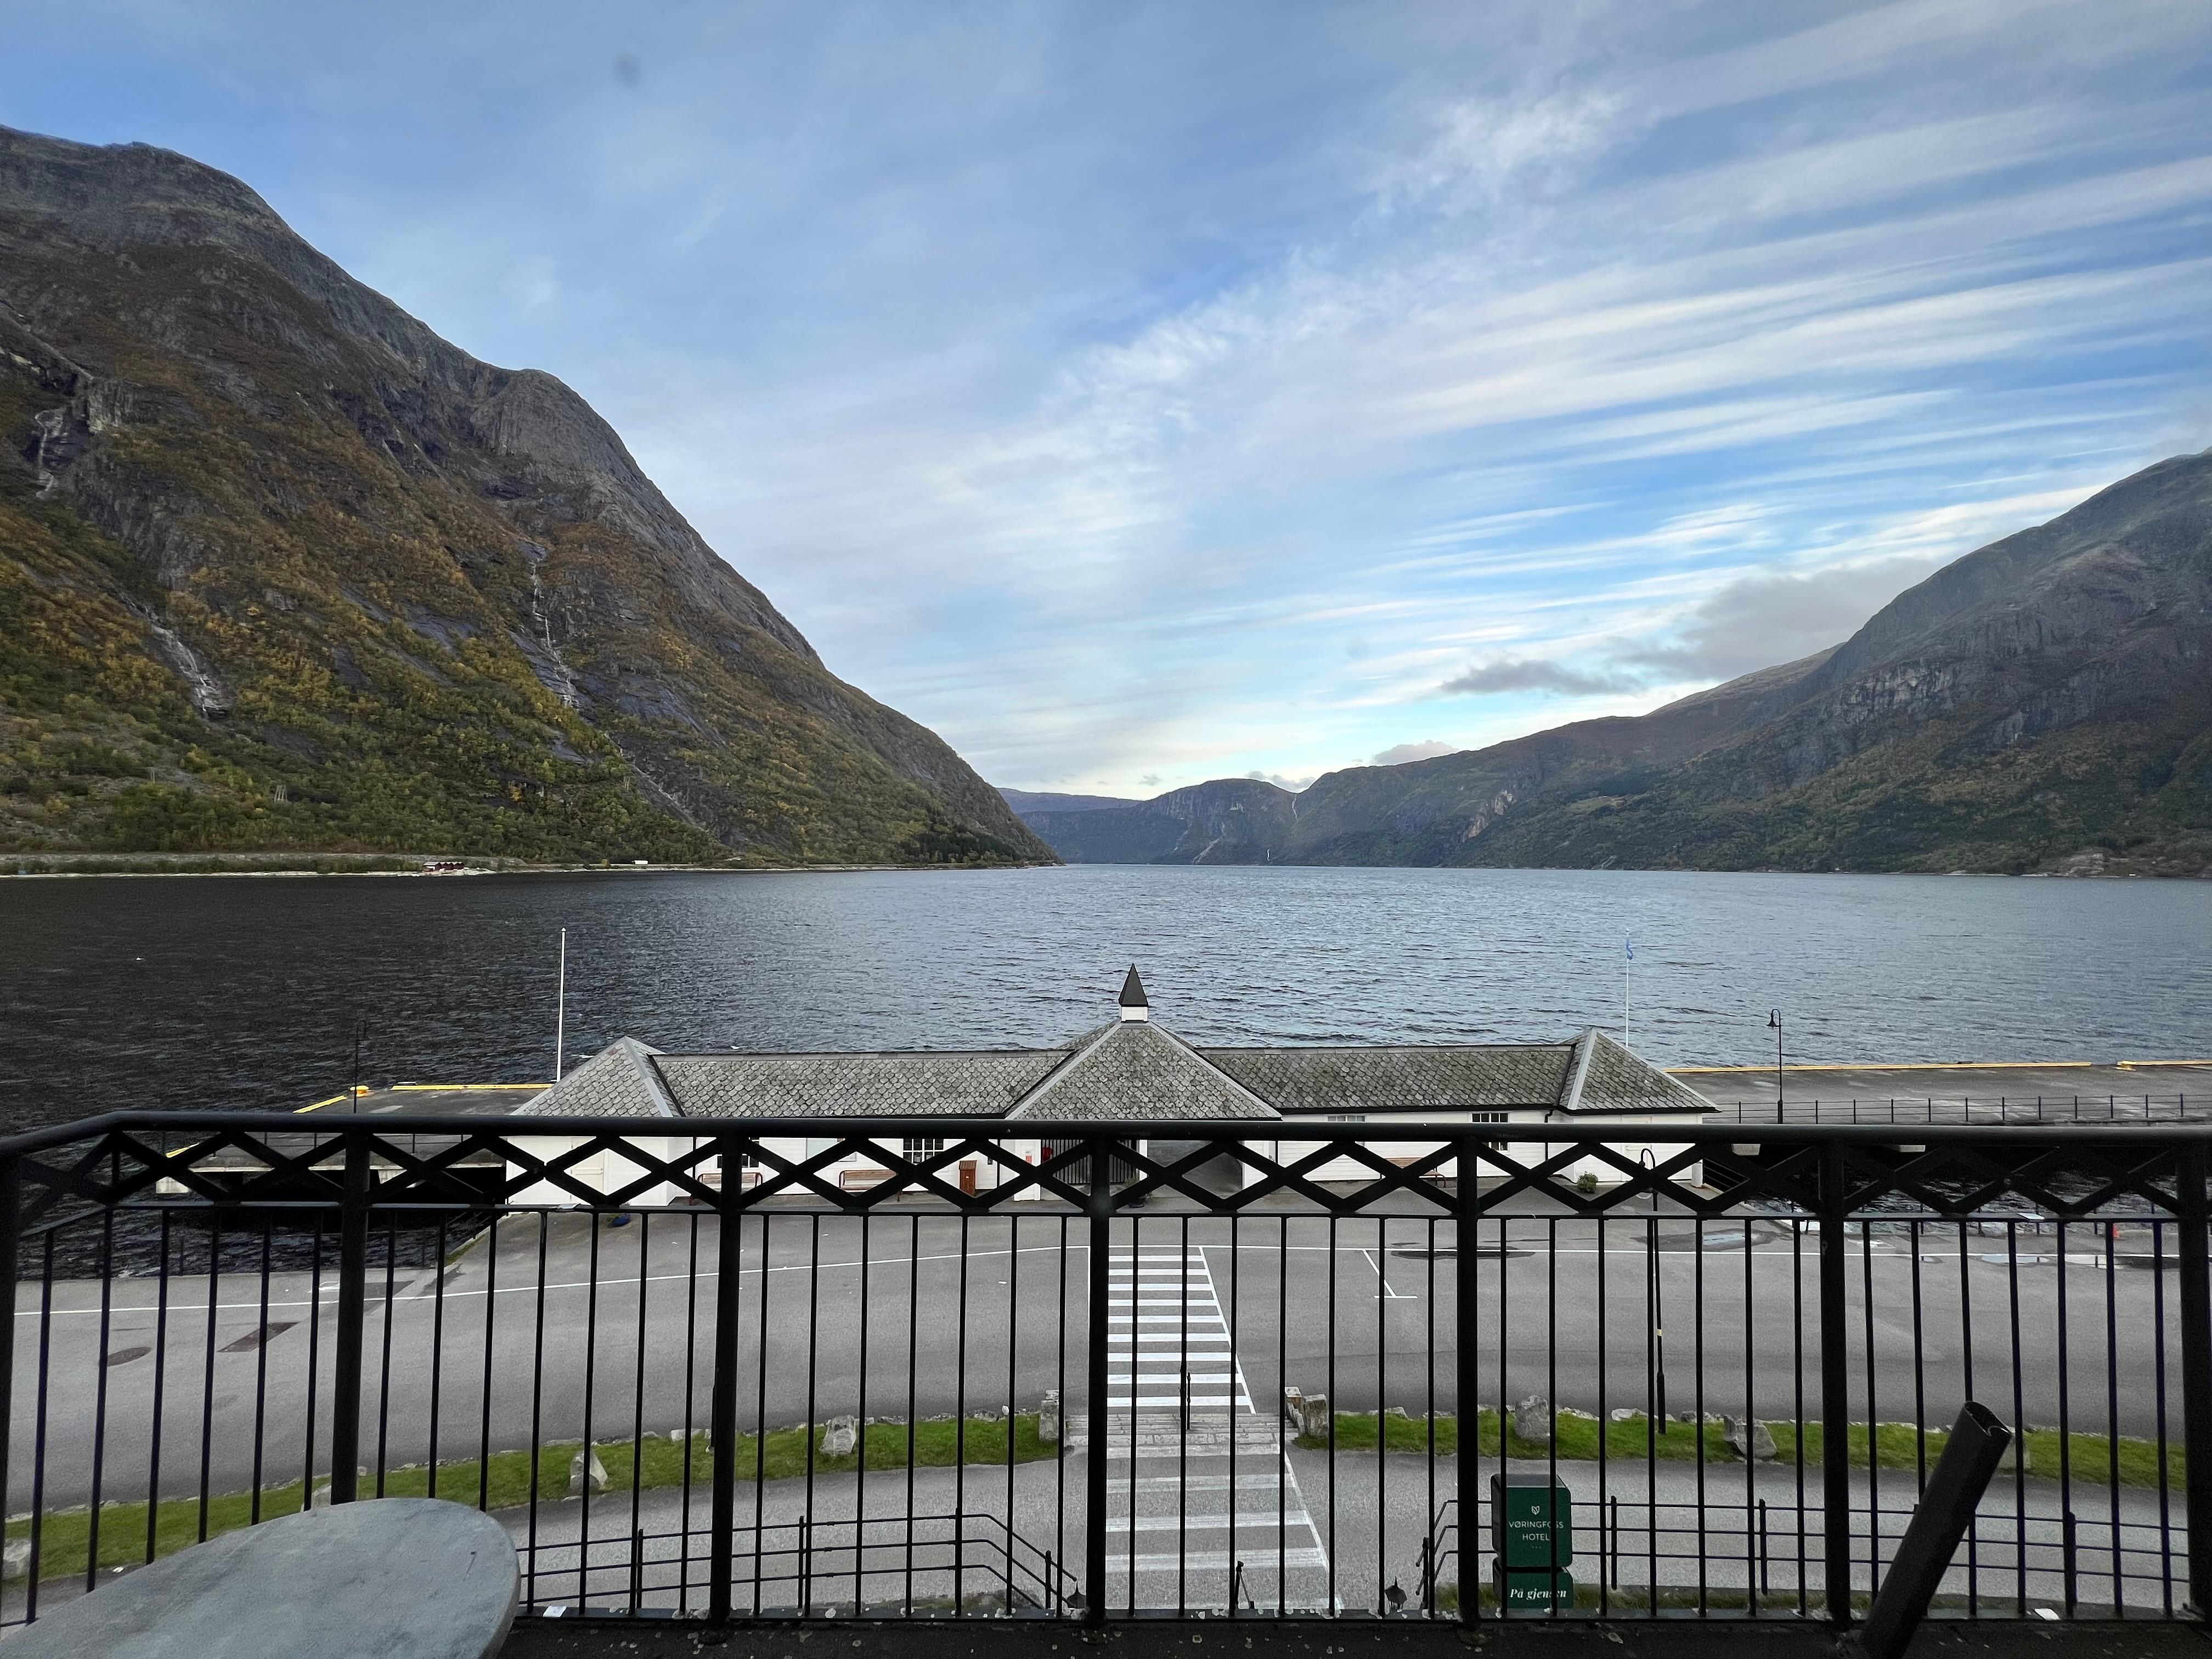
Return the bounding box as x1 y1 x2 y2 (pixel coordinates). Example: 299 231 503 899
517 967 1714 1205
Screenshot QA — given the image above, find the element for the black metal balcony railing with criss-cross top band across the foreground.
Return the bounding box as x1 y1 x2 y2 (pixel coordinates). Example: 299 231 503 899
0 1113 2212 1623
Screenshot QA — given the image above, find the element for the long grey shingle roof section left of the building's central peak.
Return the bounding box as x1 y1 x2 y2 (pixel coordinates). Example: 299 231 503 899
657 1048 1068 1117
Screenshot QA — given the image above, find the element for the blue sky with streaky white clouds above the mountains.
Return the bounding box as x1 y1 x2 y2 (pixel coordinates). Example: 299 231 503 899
0 0 2212 797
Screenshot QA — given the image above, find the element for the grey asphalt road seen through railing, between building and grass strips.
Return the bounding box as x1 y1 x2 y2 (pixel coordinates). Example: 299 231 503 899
7 1212 2181 1513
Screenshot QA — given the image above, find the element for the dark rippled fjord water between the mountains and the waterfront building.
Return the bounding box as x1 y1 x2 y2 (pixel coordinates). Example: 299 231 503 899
0 865 2212 1126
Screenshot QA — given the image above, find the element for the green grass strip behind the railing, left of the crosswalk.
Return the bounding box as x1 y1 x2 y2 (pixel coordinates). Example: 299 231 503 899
7 1415 1059 1579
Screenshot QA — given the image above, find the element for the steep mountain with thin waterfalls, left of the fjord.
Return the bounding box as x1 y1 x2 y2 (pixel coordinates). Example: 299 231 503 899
0 128 1051 865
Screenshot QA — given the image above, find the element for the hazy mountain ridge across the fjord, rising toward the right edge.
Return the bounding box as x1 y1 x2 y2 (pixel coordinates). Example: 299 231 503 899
1031 452 2212 874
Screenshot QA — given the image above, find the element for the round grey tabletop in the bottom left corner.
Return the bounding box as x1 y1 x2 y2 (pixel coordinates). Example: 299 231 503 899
7 1498 520 1659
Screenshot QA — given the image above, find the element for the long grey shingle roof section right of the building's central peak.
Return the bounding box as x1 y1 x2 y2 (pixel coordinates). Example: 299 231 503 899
1199 1042 1583 1113
